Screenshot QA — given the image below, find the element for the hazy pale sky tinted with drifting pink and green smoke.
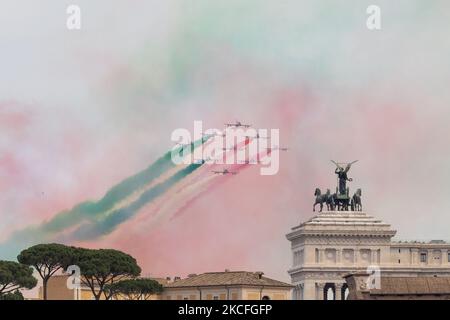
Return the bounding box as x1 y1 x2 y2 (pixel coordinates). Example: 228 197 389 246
0 0 450 288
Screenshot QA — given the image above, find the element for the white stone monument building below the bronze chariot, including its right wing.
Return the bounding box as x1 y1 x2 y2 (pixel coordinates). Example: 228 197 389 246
286 211 450 300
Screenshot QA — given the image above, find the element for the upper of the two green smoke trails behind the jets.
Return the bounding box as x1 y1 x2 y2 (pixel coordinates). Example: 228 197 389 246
0 136 211 259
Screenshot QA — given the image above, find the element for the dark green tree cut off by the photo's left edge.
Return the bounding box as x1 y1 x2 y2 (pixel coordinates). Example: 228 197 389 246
0 260 37 296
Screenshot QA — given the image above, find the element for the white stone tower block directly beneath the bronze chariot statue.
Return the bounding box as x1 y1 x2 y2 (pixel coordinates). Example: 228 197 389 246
287 211 396 300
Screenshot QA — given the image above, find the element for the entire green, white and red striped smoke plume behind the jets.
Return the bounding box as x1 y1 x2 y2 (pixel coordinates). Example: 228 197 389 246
0 131 262 257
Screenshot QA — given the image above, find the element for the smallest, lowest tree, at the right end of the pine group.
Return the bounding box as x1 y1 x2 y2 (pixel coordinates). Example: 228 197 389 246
105 278 163 300
